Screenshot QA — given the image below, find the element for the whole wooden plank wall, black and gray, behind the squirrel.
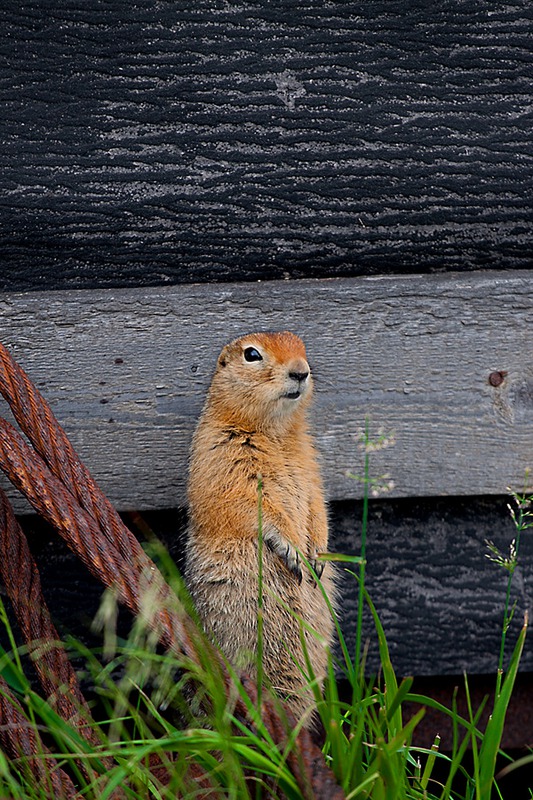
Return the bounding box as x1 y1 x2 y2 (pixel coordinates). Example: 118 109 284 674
0 0 533 675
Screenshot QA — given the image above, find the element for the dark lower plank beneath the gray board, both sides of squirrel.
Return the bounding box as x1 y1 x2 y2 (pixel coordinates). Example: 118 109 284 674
10 497 533 680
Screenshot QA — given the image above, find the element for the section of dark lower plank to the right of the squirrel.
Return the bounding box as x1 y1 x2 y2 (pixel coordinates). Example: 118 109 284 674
332 498 533 675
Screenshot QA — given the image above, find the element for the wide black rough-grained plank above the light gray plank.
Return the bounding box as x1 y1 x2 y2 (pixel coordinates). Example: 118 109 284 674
0 0 533 291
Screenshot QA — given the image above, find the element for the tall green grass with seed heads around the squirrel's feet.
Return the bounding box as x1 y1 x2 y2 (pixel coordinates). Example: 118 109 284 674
0 450 533 800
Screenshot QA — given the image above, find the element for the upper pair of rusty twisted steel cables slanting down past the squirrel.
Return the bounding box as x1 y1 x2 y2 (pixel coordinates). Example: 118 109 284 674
0 344 344 800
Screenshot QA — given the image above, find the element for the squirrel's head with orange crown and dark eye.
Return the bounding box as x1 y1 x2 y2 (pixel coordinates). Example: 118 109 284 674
210 331 312 428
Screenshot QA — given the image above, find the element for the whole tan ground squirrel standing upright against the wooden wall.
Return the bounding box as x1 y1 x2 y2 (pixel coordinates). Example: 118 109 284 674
186 332 334 715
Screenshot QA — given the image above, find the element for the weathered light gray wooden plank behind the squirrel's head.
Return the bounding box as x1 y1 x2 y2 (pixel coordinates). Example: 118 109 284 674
0 271 533 509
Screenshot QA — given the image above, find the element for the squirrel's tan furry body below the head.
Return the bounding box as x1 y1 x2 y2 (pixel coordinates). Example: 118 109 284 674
183 418 333 712
